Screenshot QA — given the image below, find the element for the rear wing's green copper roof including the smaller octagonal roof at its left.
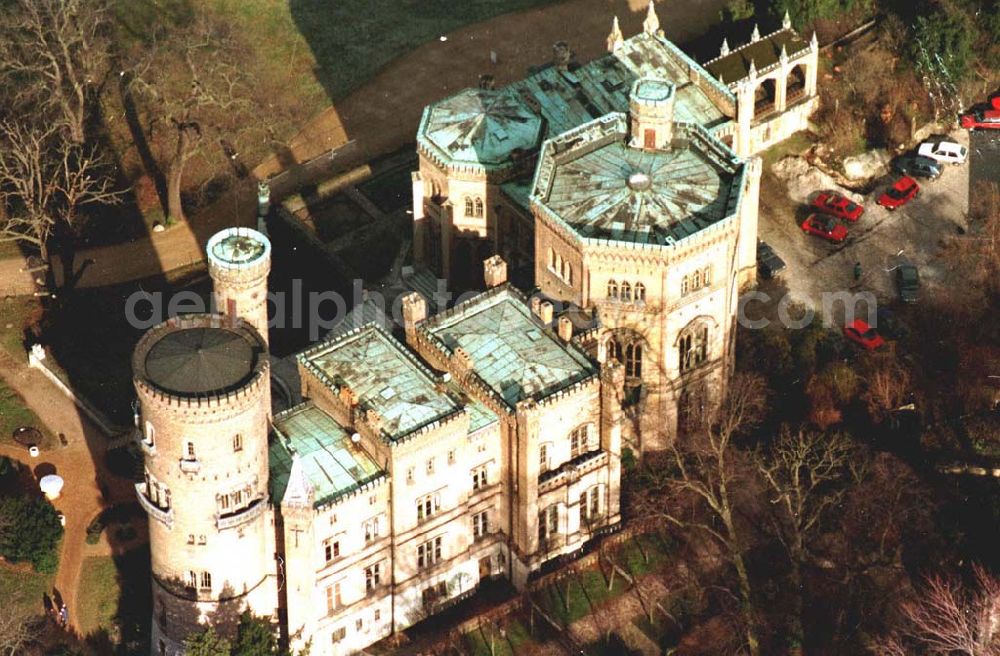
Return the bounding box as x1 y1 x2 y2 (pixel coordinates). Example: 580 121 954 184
417 33 735 170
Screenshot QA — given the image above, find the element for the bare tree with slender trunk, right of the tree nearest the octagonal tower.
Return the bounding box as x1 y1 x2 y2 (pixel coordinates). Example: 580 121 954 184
754 426 853 645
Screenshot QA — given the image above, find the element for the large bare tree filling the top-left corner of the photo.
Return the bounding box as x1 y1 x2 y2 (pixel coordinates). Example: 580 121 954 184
0 0 111 145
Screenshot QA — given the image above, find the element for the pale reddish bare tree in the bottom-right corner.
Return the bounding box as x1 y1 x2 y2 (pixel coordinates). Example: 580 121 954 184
881 566 1000 656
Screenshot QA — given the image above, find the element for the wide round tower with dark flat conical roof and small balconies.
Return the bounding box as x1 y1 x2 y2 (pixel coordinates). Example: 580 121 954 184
132 314 277 656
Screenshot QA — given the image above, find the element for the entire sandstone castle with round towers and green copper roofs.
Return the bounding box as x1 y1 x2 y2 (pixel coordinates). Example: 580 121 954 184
133 5 816 656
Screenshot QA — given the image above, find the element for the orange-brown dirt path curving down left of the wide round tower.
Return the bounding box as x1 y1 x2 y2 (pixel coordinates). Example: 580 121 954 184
0 352 134 628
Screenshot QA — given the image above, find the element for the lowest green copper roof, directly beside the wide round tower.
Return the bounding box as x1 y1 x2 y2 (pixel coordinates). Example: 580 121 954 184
269 402 386 506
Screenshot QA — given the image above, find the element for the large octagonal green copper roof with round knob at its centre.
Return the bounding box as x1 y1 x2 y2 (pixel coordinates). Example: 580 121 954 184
532 114 742 245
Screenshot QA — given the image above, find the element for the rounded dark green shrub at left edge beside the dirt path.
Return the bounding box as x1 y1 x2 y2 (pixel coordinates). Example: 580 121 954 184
0 497 63 574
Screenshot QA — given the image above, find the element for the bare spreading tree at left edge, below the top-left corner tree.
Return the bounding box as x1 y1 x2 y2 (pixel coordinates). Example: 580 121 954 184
0 121 121 262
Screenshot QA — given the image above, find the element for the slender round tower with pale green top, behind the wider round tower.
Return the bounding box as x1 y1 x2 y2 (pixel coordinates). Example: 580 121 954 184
205 227 271 342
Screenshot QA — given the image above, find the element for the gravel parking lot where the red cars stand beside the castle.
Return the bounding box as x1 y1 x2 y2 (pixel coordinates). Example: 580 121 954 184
759 130 976 321
